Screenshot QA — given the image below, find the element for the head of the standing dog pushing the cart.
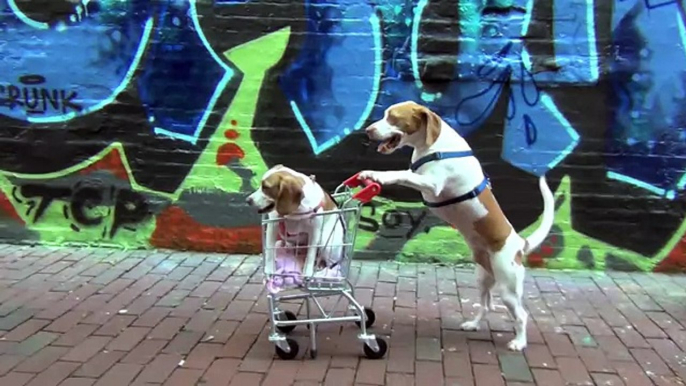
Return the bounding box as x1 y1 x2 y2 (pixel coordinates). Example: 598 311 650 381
365 102 441 154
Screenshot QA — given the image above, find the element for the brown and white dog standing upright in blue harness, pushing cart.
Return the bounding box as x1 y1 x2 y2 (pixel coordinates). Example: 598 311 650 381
360 102 554 351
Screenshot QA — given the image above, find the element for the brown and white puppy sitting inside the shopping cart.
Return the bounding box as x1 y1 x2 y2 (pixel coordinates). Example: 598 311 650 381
246 165 344 276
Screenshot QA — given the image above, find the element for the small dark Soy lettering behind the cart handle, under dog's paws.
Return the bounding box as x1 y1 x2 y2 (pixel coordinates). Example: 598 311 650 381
360 203 427 239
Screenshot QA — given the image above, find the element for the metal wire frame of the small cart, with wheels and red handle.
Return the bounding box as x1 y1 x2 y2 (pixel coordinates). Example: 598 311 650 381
262 175 388 359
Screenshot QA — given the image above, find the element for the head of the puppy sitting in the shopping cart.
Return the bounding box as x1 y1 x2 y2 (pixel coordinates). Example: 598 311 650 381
246 165 305 216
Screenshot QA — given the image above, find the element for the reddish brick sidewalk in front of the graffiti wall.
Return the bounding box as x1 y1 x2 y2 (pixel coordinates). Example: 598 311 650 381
0 246 686 386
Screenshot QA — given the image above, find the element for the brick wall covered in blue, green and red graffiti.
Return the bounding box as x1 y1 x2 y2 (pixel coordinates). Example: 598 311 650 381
0 0 686 271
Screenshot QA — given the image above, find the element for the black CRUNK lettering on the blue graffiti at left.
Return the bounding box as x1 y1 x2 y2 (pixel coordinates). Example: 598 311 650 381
0 75 83 115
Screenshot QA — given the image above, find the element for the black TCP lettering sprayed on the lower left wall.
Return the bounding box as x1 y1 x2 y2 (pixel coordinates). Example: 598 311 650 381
12 183 151 237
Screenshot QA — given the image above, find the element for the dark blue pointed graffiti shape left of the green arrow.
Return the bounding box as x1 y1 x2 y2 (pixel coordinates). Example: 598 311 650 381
144 0 234 143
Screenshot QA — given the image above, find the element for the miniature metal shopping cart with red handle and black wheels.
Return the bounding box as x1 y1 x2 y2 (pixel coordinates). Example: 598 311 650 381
262 175 388 359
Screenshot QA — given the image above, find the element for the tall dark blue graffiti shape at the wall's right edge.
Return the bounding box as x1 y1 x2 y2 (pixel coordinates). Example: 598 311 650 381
606 0 686 199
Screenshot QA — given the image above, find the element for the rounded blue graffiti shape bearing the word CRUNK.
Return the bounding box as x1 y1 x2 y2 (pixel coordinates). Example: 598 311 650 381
0 0 153 123
